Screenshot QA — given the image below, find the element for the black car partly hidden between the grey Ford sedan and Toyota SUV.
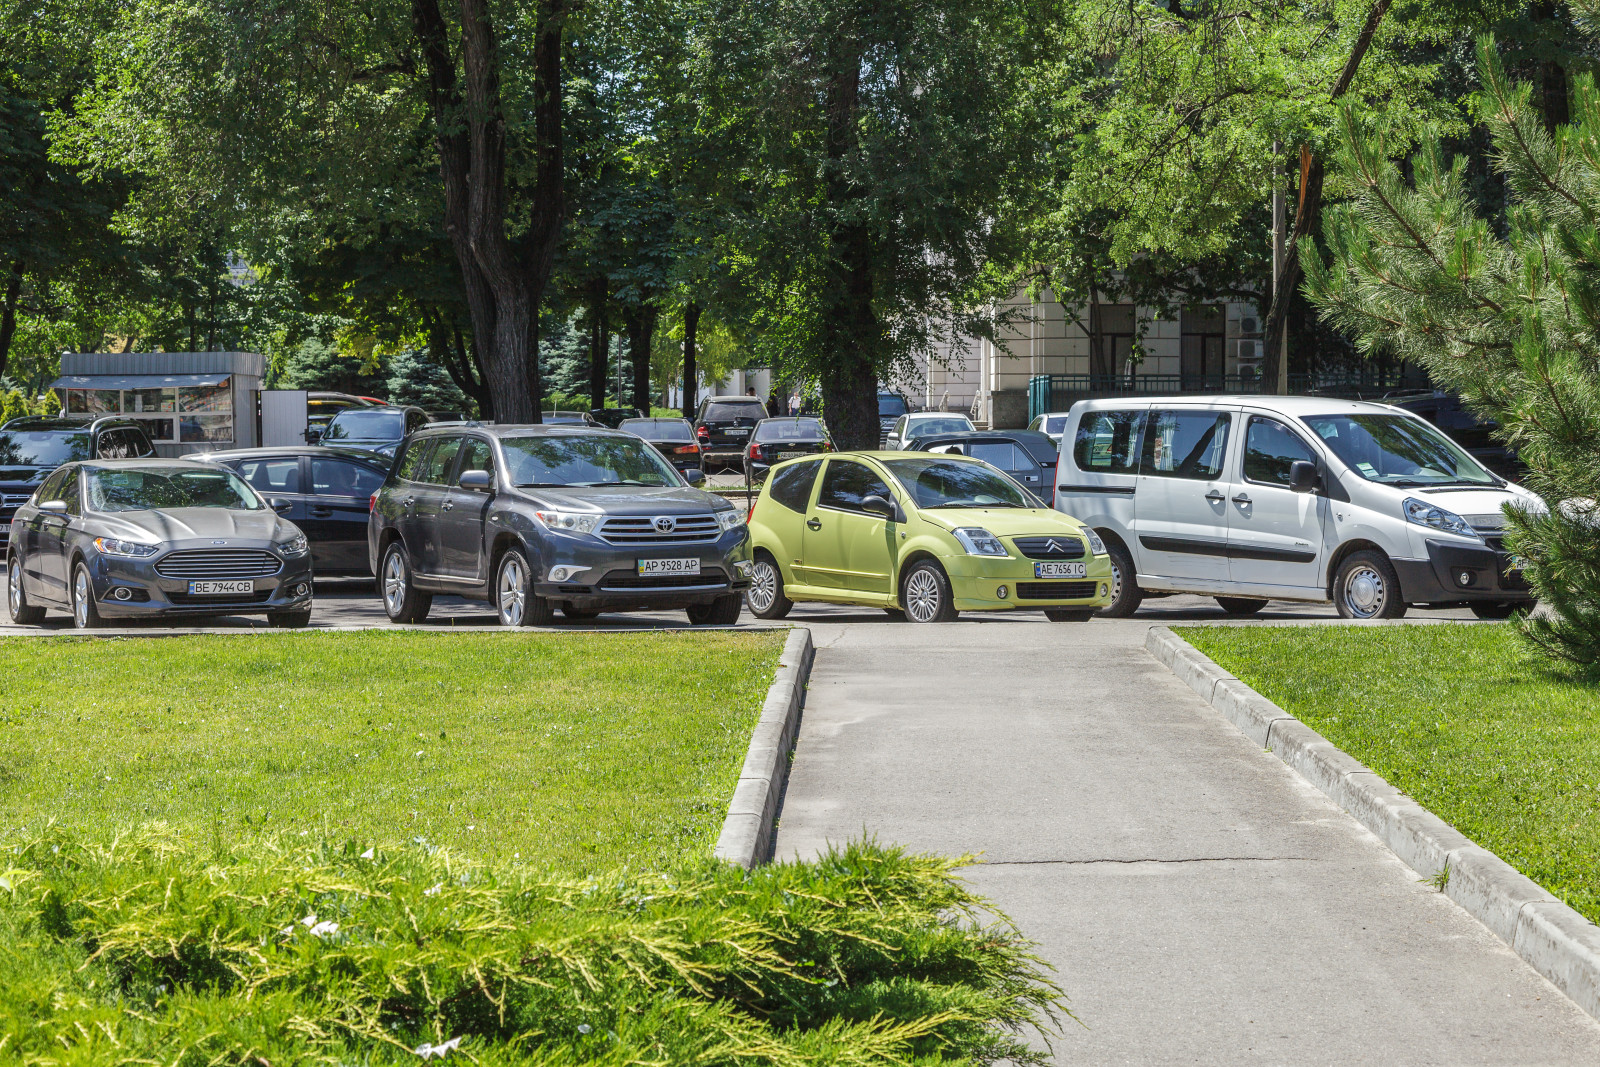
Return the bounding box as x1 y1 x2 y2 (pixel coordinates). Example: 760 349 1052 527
190 445 392 577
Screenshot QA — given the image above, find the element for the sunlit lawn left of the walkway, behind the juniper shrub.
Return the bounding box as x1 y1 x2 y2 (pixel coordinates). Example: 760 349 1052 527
0 632 784 872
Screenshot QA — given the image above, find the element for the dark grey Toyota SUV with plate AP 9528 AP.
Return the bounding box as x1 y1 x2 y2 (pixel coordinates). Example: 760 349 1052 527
366 426 750 625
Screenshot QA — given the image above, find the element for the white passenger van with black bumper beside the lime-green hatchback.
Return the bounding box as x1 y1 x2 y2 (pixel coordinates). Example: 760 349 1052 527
1056 397 1544 619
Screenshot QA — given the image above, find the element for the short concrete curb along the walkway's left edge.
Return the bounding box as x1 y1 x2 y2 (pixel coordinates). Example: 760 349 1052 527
715 627 816 869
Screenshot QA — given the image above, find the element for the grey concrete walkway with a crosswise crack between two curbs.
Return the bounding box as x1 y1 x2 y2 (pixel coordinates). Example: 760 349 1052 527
778 598 1600 1067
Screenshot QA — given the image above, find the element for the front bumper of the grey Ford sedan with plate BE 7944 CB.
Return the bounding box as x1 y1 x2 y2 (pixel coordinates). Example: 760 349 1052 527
90 555 312 619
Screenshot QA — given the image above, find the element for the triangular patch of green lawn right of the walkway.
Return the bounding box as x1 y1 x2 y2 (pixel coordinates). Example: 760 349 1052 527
1178 625 1600 921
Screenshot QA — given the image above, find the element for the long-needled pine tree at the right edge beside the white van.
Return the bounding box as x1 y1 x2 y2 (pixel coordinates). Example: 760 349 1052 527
1301 38 1600 665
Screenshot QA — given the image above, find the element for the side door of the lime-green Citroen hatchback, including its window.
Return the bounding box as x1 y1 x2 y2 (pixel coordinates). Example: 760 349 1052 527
803 458 898 598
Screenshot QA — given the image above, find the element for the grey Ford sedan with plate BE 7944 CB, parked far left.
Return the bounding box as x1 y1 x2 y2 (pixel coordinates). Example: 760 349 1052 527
6 459 312 629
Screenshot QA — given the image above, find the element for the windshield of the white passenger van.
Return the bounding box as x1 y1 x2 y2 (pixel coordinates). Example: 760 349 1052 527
1302 413 1501 486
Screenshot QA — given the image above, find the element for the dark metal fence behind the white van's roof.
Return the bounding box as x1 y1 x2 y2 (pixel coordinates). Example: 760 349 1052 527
1027 368 1432 419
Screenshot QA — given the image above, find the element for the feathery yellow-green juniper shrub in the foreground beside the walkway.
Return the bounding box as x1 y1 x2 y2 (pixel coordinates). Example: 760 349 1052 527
0 827 1059 1067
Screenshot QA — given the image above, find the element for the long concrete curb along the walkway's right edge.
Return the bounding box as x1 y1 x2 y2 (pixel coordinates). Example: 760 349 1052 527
1144 625 1600 1019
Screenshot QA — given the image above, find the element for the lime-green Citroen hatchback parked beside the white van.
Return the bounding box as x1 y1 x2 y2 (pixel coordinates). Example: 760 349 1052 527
746 453 1112 622
